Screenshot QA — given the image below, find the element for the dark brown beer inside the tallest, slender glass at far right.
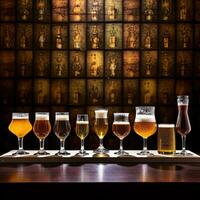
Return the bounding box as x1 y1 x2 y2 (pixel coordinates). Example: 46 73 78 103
176 104 191 136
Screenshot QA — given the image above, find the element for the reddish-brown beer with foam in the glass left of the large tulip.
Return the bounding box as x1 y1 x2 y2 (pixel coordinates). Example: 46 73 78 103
112 122 131 140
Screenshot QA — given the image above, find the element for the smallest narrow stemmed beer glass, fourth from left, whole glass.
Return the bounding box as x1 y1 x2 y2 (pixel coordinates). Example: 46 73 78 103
76 114 89 156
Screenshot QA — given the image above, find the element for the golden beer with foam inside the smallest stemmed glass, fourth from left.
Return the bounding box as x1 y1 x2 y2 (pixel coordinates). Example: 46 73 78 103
76 121 89 140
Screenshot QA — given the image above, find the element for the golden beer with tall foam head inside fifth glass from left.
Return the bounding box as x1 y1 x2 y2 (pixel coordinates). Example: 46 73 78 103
95 110 108 139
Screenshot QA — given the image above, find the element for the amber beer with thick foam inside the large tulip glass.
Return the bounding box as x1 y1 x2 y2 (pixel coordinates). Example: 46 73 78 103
134 115 157 139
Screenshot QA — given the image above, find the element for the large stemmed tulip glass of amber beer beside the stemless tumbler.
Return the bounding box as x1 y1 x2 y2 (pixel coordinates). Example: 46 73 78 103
133 106 157 155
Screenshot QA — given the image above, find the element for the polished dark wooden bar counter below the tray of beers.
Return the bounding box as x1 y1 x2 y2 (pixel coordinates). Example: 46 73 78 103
0 163 200 199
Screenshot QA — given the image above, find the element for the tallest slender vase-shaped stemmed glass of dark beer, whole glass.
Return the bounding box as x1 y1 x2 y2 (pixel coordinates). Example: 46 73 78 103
176 96 191 156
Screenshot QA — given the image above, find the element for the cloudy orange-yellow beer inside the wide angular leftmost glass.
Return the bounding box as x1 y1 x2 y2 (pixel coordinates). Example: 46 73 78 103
8 119 32 138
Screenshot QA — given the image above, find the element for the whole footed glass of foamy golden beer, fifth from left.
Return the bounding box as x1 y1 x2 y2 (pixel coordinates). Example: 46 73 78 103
94 109 108 153
